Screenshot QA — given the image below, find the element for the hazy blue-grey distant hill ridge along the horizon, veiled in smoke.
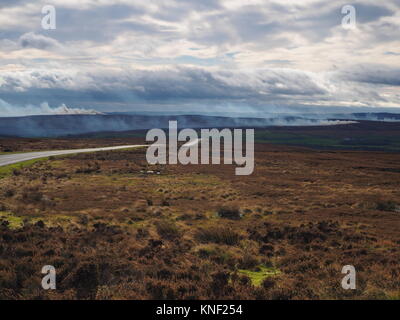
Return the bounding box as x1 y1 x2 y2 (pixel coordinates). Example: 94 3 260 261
0 113 400 137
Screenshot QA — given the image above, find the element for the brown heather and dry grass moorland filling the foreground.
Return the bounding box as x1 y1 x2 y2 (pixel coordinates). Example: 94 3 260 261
0 142 400 299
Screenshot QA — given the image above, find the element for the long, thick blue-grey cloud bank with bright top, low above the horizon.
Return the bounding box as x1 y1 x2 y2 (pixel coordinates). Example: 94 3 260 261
0 68 325 100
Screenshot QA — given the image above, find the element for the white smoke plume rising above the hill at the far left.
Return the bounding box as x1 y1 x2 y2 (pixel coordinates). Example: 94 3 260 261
0 99 102 117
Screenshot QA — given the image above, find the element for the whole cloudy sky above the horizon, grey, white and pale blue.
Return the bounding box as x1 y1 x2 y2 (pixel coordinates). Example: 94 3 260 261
0 0 400 116
